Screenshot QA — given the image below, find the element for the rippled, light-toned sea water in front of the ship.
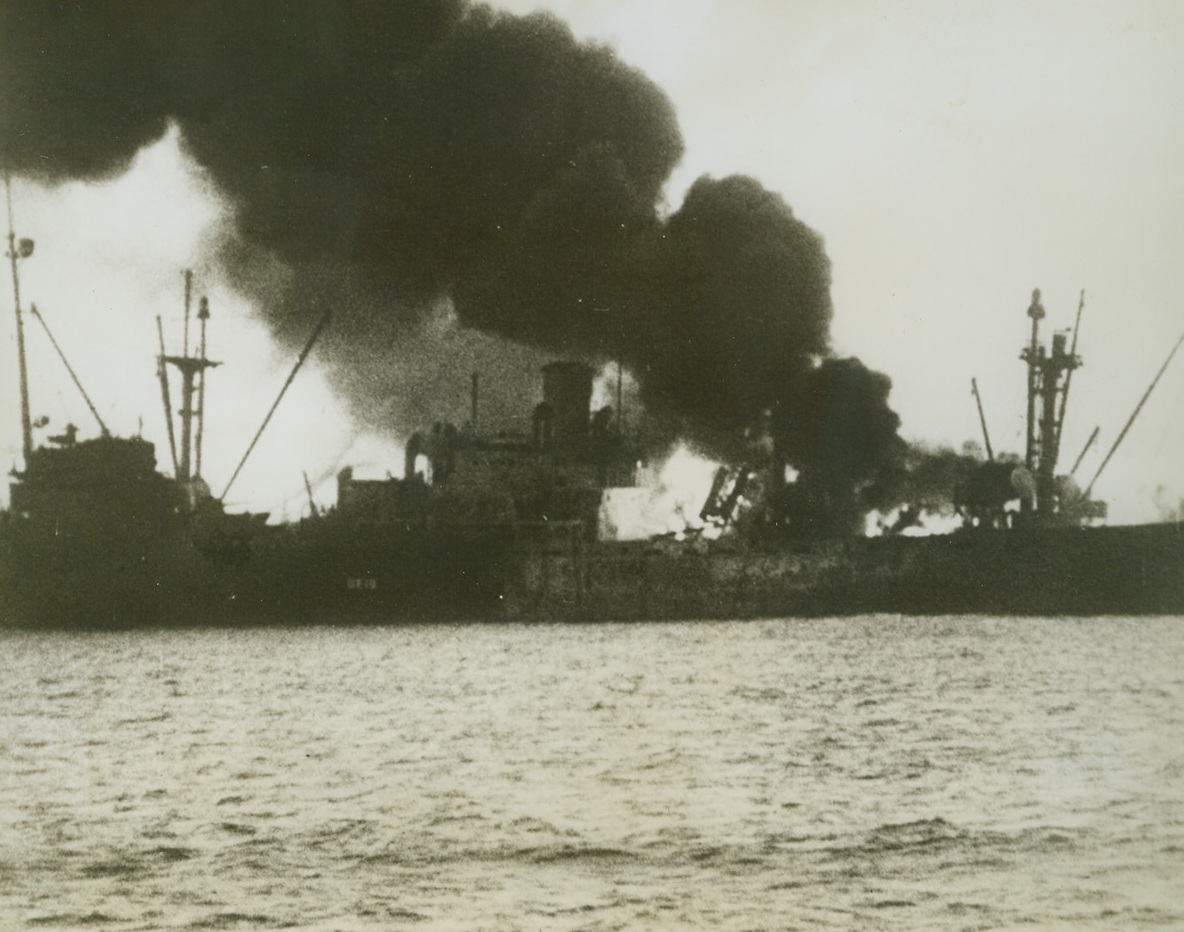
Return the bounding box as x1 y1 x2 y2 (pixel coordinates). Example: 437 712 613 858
0 617 1184 931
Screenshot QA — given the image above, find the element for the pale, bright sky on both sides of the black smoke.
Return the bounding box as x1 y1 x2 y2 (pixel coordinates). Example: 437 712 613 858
0 0 1184 522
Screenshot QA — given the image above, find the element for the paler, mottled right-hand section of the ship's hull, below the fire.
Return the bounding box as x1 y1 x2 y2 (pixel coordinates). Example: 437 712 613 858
508 525 1184 619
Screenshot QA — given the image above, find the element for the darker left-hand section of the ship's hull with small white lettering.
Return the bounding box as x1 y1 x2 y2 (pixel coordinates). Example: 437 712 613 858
0 516 508 629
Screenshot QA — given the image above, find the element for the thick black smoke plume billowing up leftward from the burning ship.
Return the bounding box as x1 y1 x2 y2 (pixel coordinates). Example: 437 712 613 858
0 0 897 525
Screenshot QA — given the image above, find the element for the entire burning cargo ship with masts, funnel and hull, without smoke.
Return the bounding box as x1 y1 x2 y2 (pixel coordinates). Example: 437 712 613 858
0 191 1184 626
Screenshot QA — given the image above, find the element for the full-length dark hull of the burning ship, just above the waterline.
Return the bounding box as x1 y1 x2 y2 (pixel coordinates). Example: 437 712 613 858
0 522 1184 628
